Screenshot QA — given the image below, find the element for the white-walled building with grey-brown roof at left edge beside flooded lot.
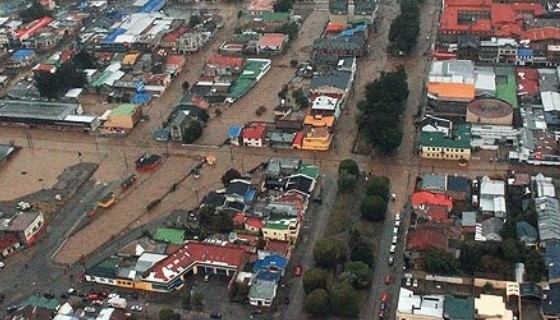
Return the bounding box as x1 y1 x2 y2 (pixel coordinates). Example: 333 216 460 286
0 211 45 246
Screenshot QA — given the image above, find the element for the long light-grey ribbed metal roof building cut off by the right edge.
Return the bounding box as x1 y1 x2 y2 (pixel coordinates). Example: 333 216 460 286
535 197 560 245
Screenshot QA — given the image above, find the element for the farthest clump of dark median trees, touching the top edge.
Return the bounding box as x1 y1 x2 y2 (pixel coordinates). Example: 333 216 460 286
389 0 420 56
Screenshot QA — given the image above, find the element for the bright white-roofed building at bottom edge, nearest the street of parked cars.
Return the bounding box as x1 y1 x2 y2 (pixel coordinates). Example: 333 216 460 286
395 287 445 320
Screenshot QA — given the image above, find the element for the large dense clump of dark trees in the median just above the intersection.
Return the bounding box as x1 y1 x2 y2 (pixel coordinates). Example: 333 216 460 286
357 66 409 153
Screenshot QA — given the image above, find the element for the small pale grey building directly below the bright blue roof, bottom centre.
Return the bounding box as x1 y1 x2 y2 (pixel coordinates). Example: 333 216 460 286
247 270 281 307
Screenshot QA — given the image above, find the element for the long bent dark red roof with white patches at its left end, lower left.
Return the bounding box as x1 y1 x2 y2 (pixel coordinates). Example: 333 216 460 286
145 242 245 283
